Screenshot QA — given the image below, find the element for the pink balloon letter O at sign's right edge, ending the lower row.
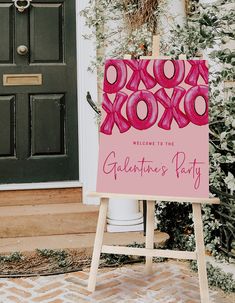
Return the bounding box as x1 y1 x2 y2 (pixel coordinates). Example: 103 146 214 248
184 85 208 125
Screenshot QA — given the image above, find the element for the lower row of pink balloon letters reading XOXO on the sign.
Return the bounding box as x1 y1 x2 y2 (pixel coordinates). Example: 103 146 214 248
100 85 208 135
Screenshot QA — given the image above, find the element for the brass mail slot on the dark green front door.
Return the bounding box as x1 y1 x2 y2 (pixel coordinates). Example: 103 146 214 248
3 74 42 86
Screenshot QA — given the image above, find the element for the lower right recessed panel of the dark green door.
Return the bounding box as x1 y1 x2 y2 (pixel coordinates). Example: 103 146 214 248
31 94 66 156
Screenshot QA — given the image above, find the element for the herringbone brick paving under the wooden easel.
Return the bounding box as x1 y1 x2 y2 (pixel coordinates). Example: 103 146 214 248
0 261 235 303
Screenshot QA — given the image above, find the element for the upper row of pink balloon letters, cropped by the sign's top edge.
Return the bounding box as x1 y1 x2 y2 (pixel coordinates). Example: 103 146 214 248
104 59 208 94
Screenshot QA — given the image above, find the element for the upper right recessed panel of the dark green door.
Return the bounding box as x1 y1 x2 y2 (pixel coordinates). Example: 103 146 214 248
30 3 63 63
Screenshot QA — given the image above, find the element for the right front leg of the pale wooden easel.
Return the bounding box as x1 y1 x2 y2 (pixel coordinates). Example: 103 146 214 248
193 203 209 303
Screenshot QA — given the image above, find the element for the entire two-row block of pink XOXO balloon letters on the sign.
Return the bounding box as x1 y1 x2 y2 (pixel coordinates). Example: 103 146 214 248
100 59 208 135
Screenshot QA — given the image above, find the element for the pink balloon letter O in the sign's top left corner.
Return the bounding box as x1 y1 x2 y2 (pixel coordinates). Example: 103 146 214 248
104 60 127 94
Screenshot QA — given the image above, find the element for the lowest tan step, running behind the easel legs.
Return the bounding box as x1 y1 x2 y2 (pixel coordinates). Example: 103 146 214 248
0 231 169 255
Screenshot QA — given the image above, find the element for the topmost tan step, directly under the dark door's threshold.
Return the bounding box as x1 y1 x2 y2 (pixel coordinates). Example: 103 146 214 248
0 187 82 206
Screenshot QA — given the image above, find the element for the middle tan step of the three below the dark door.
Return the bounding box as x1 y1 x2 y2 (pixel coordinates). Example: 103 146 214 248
0 203 99 238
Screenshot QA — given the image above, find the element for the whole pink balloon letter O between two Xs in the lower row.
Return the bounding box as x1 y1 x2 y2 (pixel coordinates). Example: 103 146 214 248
126 90 158 130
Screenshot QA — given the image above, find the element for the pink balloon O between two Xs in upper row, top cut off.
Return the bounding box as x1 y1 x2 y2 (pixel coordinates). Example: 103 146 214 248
153 60 185 88
